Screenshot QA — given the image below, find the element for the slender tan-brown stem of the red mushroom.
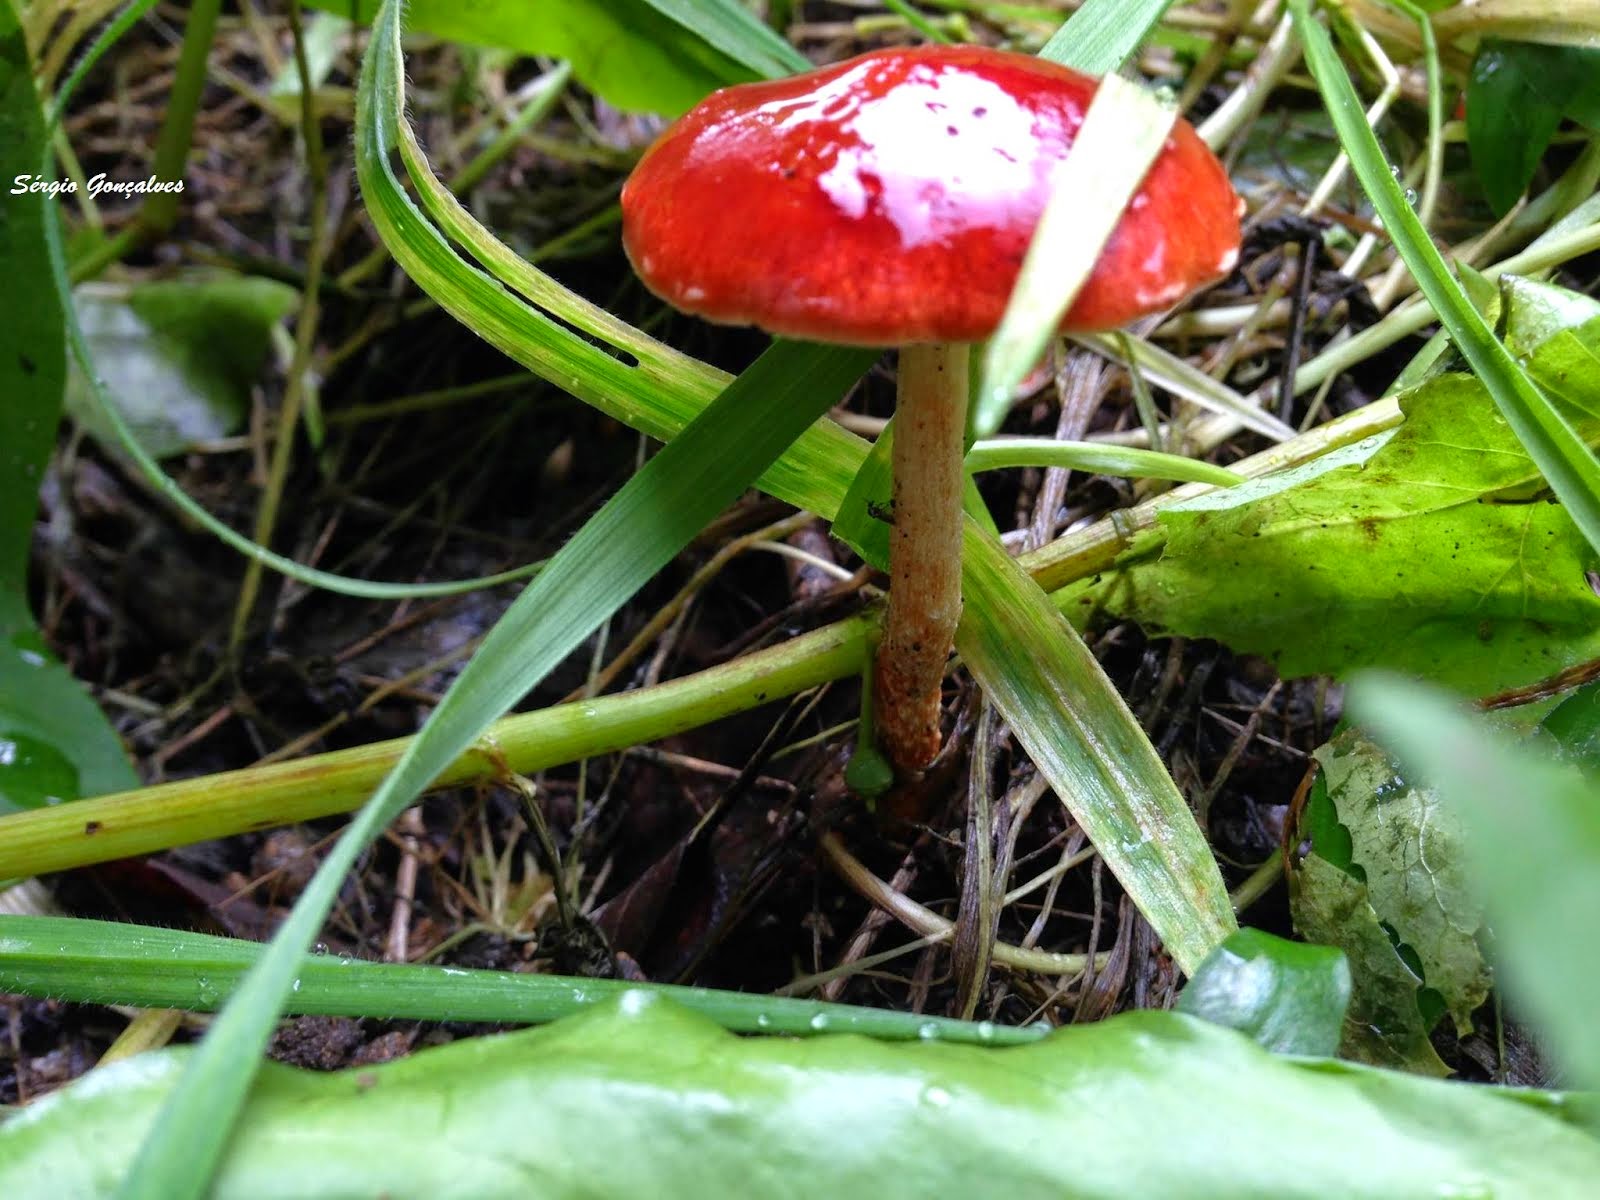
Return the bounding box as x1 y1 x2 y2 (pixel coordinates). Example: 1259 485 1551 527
877 342 968 778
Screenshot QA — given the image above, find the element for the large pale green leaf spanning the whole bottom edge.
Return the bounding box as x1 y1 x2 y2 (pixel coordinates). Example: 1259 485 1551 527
12 994 1600 1200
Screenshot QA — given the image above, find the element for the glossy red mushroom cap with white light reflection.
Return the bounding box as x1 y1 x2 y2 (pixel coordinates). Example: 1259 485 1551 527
622 46 1243 346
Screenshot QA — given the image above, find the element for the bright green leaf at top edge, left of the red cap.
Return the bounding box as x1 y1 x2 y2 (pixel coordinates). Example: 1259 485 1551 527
307 0 780 115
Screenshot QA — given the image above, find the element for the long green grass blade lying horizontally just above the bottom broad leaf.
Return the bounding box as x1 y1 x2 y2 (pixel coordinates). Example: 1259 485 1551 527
0 915 1045 1045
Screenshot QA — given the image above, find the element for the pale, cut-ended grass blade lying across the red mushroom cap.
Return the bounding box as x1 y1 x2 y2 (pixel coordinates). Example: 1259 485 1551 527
973 75 1178 437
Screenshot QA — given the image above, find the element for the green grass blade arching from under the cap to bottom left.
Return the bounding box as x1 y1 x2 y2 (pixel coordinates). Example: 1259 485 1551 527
123 342 876 1200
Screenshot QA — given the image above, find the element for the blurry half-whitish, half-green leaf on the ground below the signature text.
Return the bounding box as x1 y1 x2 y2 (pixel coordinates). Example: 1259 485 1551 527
67 274 299 458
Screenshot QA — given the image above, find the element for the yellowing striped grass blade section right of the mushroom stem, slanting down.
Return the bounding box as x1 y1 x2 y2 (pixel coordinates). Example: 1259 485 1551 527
955 522 1237 973
